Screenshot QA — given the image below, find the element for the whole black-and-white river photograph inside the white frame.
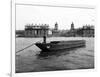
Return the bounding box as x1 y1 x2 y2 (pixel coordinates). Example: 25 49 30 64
15 4 95 73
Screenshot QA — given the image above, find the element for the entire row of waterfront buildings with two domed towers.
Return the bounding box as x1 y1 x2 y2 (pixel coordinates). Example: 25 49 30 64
16 22 94 37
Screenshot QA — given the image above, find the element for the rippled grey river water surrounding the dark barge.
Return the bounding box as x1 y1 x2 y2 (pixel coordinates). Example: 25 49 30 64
16 37 94 72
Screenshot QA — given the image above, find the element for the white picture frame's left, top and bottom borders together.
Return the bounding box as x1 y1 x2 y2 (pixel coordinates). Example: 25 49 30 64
11 0 96 77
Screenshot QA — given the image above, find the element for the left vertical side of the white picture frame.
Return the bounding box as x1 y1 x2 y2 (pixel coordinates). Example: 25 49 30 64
11 0 16 77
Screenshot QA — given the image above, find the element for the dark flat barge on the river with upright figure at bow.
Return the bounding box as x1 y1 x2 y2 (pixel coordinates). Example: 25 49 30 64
35 36 86 52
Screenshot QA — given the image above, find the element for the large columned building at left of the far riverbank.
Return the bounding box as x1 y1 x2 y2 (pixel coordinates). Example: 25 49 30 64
25 24 49 37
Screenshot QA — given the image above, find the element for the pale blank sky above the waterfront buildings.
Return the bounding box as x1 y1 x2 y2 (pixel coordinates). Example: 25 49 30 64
16 5 95 30
